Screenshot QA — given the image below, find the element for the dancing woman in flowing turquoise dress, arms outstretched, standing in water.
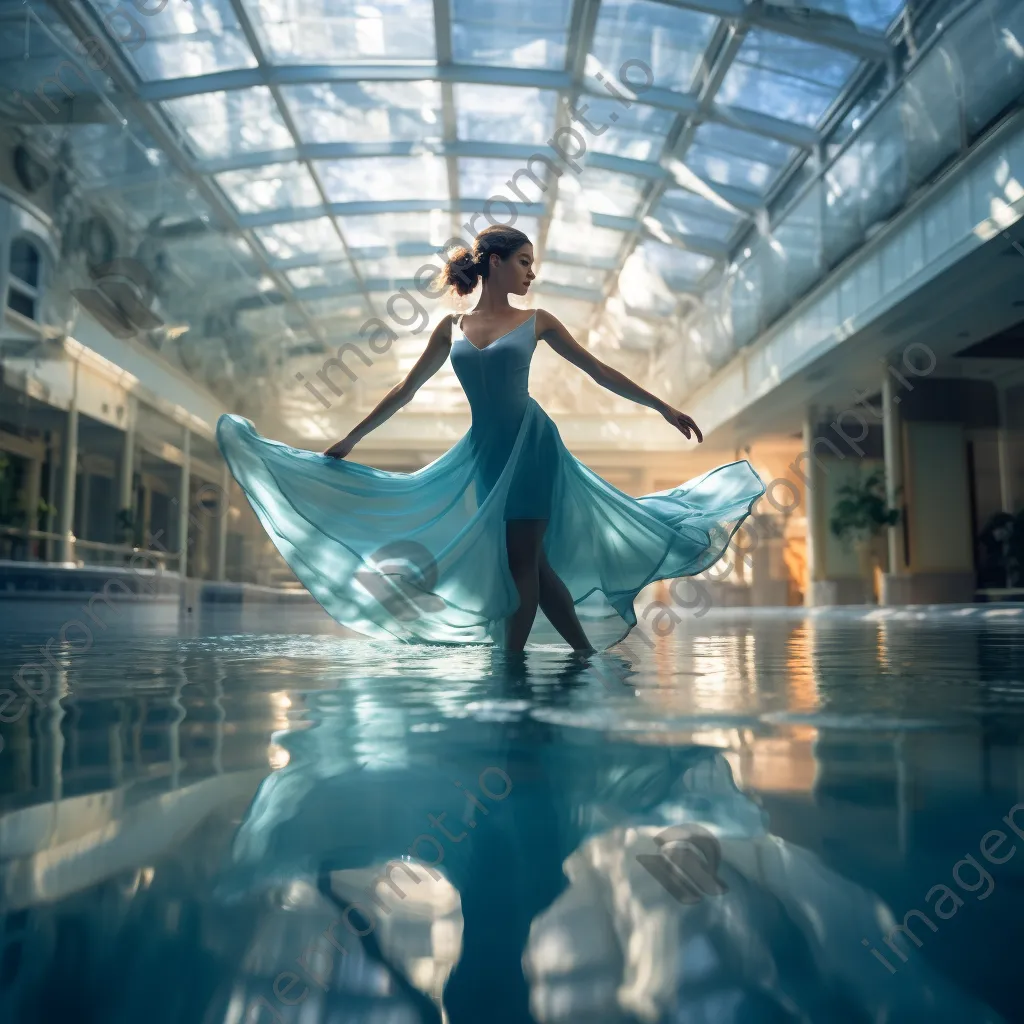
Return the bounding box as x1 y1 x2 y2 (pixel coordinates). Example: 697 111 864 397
217 225 764 652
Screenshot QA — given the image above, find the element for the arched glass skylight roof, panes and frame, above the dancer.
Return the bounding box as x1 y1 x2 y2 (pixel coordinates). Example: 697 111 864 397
6 0 902 376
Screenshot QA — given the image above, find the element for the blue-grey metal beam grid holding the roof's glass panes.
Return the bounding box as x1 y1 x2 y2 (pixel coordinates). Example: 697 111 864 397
51 0 894 382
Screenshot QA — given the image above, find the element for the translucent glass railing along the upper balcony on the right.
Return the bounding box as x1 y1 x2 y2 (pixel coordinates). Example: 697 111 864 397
687 0 1024 387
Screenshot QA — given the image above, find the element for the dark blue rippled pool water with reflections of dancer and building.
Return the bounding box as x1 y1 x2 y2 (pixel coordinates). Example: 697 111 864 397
0 617 1024 1024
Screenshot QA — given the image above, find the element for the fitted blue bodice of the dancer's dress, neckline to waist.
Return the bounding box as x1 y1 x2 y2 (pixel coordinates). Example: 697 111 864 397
452 312 537 427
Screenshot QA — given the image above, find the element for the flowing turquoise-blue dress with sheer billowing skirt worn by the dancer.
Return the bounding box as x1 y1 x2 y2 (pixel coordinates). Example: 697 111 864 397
217 314 764 650
